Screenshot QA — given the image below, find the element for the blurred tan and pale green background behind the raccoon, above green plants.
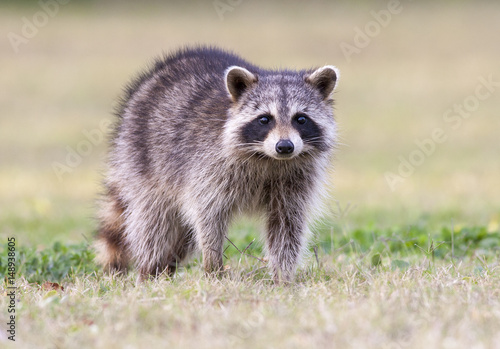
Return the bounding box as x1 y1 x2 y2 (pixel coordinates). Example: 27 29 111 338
0 0 500 246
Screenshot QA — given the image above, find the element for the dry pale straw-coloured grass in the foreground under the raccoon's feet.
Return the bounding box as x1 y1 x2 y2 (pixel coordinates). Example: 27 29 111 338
0 239 500 348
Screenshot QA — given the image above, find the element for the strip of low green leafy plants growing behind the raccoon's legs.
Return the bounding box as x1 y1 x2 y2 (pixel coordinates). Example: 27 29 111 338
0 223 500 284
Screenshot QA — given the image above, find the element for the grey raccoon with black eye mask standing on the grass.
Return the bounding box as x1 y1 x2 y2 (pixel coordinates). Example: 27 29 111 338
96 47 339 282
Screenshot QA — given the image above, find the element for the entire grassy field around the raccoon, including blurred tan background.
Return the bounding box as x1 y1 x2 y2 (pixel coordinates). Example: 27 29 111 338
0 0 500 348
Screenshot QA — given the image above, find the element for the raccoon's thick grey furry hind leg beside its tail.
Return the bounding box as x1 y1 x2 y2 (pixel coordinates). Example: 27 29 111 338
125 198 196 280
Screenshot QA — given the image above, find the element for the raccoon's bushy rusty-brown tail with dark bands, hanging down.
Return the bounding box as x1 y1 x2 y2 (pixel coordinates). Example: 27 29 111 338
95 187 129 272
